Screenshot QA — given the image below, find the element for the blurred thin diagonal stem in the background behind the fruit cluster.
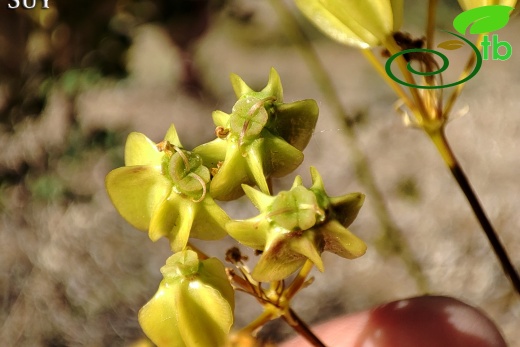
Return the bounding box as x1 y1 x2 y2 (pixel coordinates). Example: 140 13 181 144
271 0 428 293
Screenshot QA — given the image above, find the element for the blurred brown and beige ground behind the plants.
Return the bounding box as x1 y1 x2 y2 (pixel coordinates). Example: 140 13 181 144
0 0 520 347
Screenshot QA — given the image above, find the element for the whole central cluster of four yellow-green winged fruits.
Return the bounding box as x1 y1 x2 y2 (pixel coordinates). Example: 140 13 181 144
106 69 366 347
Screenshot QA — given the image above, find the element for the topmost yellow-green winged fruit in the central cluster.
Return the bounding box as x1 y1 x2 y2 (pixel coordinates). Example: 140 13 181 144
193 69 318 200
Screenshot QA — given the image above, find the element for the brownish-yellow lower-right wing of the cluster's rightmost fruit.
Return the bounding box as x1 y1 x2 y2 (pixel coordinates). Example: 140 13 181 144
320 220 367 259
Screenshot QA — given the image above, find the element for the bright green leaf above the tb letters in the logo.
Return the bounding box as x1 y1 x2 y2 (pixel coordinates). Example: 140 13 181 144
453 5 514 35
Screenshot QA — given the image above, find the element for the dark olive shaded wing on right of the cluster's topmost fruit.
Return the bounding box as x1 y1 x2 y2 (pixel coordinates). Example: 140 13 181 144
269 100 319 151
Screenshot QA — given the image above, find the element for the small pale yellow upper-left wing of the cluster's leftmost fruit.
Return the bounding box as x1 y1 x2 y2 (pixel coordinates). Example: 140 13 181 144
125 132 164 166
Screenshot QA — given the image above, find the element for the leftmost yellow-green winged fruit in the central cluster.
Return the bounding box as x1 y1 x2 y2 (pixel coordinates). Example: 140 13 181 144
106 125 229 252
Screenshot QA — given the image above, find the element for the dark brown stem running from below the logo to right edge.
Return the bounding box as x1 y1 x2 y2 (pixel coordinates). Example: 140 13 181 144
428 129 520 294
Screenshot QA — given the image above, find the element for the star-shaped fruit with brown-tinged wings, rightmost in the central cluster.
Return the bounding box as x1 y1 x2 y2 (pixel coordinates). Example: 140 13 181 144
226 167 366 282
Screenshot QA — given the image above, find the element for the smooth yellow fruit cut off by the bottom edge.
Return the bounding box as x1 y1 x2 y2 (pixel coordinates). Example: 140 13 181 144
139 250 235 347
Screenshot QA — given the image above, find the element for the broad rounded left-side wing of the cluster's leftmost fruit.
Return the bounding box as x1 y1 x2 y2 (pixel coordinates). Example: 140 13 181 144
105 166 172 231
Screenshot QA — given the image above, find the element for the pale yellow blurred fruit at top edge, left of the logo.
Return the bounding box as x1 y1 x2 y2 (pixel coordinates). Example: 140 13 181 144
295 0 403 48
